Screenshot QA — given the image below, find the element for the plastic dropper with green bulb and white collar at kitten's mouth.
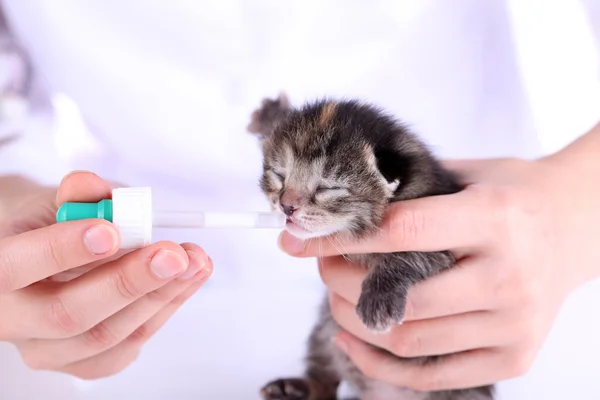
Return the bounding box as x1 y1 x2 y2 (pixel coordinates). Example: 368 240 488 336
56 187 286 249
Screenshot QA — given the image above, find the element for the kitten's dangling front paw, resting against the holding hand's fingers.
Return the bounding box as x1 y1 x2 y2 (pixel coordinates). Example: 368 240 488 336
356 290 406 333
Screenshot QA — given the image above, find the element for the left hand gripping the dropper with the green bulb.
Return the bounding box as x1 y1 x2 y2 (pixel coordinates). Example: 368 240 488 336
0 172 212 379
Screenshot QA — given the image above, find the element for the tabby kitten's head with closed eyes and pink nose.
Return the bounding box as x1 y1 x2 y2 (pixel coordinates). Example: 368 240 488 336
255 101 414 239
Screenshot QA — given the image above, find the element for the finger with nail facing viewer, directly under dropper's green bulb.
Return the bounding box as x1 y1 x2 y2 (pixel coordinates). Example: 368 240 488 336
0 219 120 293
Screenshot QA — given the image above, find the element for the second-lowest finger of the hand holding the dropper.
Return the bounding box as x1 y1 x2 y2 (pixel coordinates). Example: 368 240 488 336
20 245 212 370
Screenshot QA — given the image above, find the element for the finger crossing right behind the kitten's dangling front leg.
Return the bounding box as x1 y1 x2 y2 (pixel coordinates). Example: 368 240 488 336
319 257 492 322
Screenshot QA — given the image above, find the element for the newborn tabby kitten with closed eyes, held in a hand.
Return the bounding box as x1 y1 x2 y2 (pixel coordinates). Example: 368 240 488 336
248 95 493 400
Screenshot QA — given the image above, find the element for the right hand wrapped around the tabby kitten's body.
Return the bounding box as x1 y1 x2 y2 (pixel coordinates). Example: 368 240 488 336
280 158 600 391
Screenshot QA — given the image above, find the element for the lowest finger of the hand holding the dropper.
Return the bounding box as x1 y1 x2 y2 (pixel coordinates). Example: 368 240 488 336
61 281 203 379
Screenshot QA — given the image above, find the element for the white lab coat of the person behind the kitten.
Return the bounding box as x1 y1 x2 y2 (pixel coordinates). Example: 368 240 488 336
0 0 600 400
